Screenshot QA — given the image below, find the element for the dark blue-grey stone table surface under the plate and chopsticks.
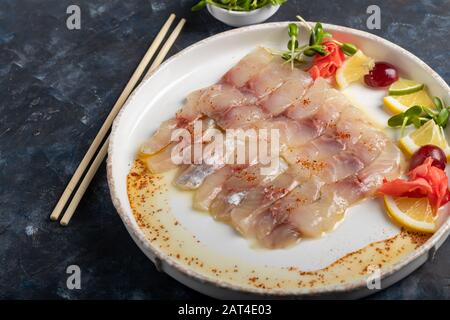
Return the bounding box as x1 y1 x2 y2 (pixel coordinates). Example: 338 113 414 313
0 0 450 299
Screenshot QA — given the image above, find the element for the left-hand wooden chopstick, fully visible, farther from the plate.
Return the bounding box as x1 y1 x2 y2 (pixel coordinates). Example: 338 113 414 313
50 13 175 220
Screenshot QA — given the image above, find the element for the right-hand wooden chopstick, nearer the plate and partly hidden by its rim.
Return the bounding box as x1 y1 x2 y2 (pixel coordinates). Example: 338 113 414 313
60 19 186 226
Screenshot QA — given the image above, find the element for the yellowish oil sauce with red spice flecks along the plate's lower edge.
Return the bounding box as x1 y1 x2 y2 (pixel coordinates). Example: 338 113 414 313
127 160 429 290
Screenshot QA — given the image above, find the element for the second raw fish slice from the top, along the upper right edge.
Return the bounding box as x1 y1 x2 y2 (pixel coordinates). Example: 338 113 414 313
247 57 306 98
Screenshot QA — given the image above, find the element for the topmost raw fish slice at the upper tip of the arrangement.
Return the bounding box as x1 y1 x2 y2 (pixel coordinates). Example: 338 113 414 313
222 47 273 88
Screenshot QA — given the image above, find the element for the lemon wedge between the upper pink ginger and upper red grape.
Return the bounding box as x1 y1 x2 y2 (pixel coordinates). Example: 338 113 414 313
336 50 375 89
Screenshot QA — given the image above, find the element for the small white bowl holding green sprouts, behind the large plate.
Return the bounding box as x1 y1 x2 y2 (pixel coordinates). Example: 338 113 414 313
206 3 280 27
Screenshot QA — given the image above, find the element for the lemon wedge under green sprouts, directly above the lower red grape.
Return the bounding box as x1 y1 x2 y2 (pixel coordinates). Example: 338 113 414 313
399 120 450 159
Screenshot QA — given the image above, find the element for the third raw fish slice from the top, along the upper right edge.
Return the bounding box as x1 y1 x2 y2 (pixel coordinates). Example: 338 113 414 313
261 73 312 116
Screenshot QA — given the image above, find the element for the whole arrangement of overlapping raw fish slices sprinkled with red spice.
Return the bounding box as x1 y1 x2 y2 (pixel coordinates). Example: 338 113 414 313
140 48 403 248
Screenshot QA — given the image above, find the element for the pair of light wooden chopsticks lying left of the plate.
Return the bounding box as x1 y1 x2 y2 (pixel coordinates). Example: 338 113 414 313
50 13 186 226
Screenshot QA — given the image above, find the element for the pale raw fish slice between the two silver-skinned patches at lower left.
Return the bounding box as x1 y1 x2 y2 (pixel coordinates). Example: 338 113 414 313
193 166 231 211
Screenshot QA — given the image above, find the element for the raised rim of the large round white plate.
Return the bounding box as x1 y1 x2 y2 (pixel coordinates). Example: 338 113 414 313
106 21 450 297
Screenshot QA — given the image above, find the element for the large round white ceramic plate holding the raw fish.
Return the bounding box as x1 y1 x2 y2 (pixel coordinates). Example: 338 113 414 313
108 22 450 298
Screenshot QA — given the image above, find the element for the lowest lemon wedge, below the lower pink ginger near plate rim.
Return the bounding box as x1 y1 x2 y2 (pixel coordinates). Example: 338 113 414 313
384 196 436 233
